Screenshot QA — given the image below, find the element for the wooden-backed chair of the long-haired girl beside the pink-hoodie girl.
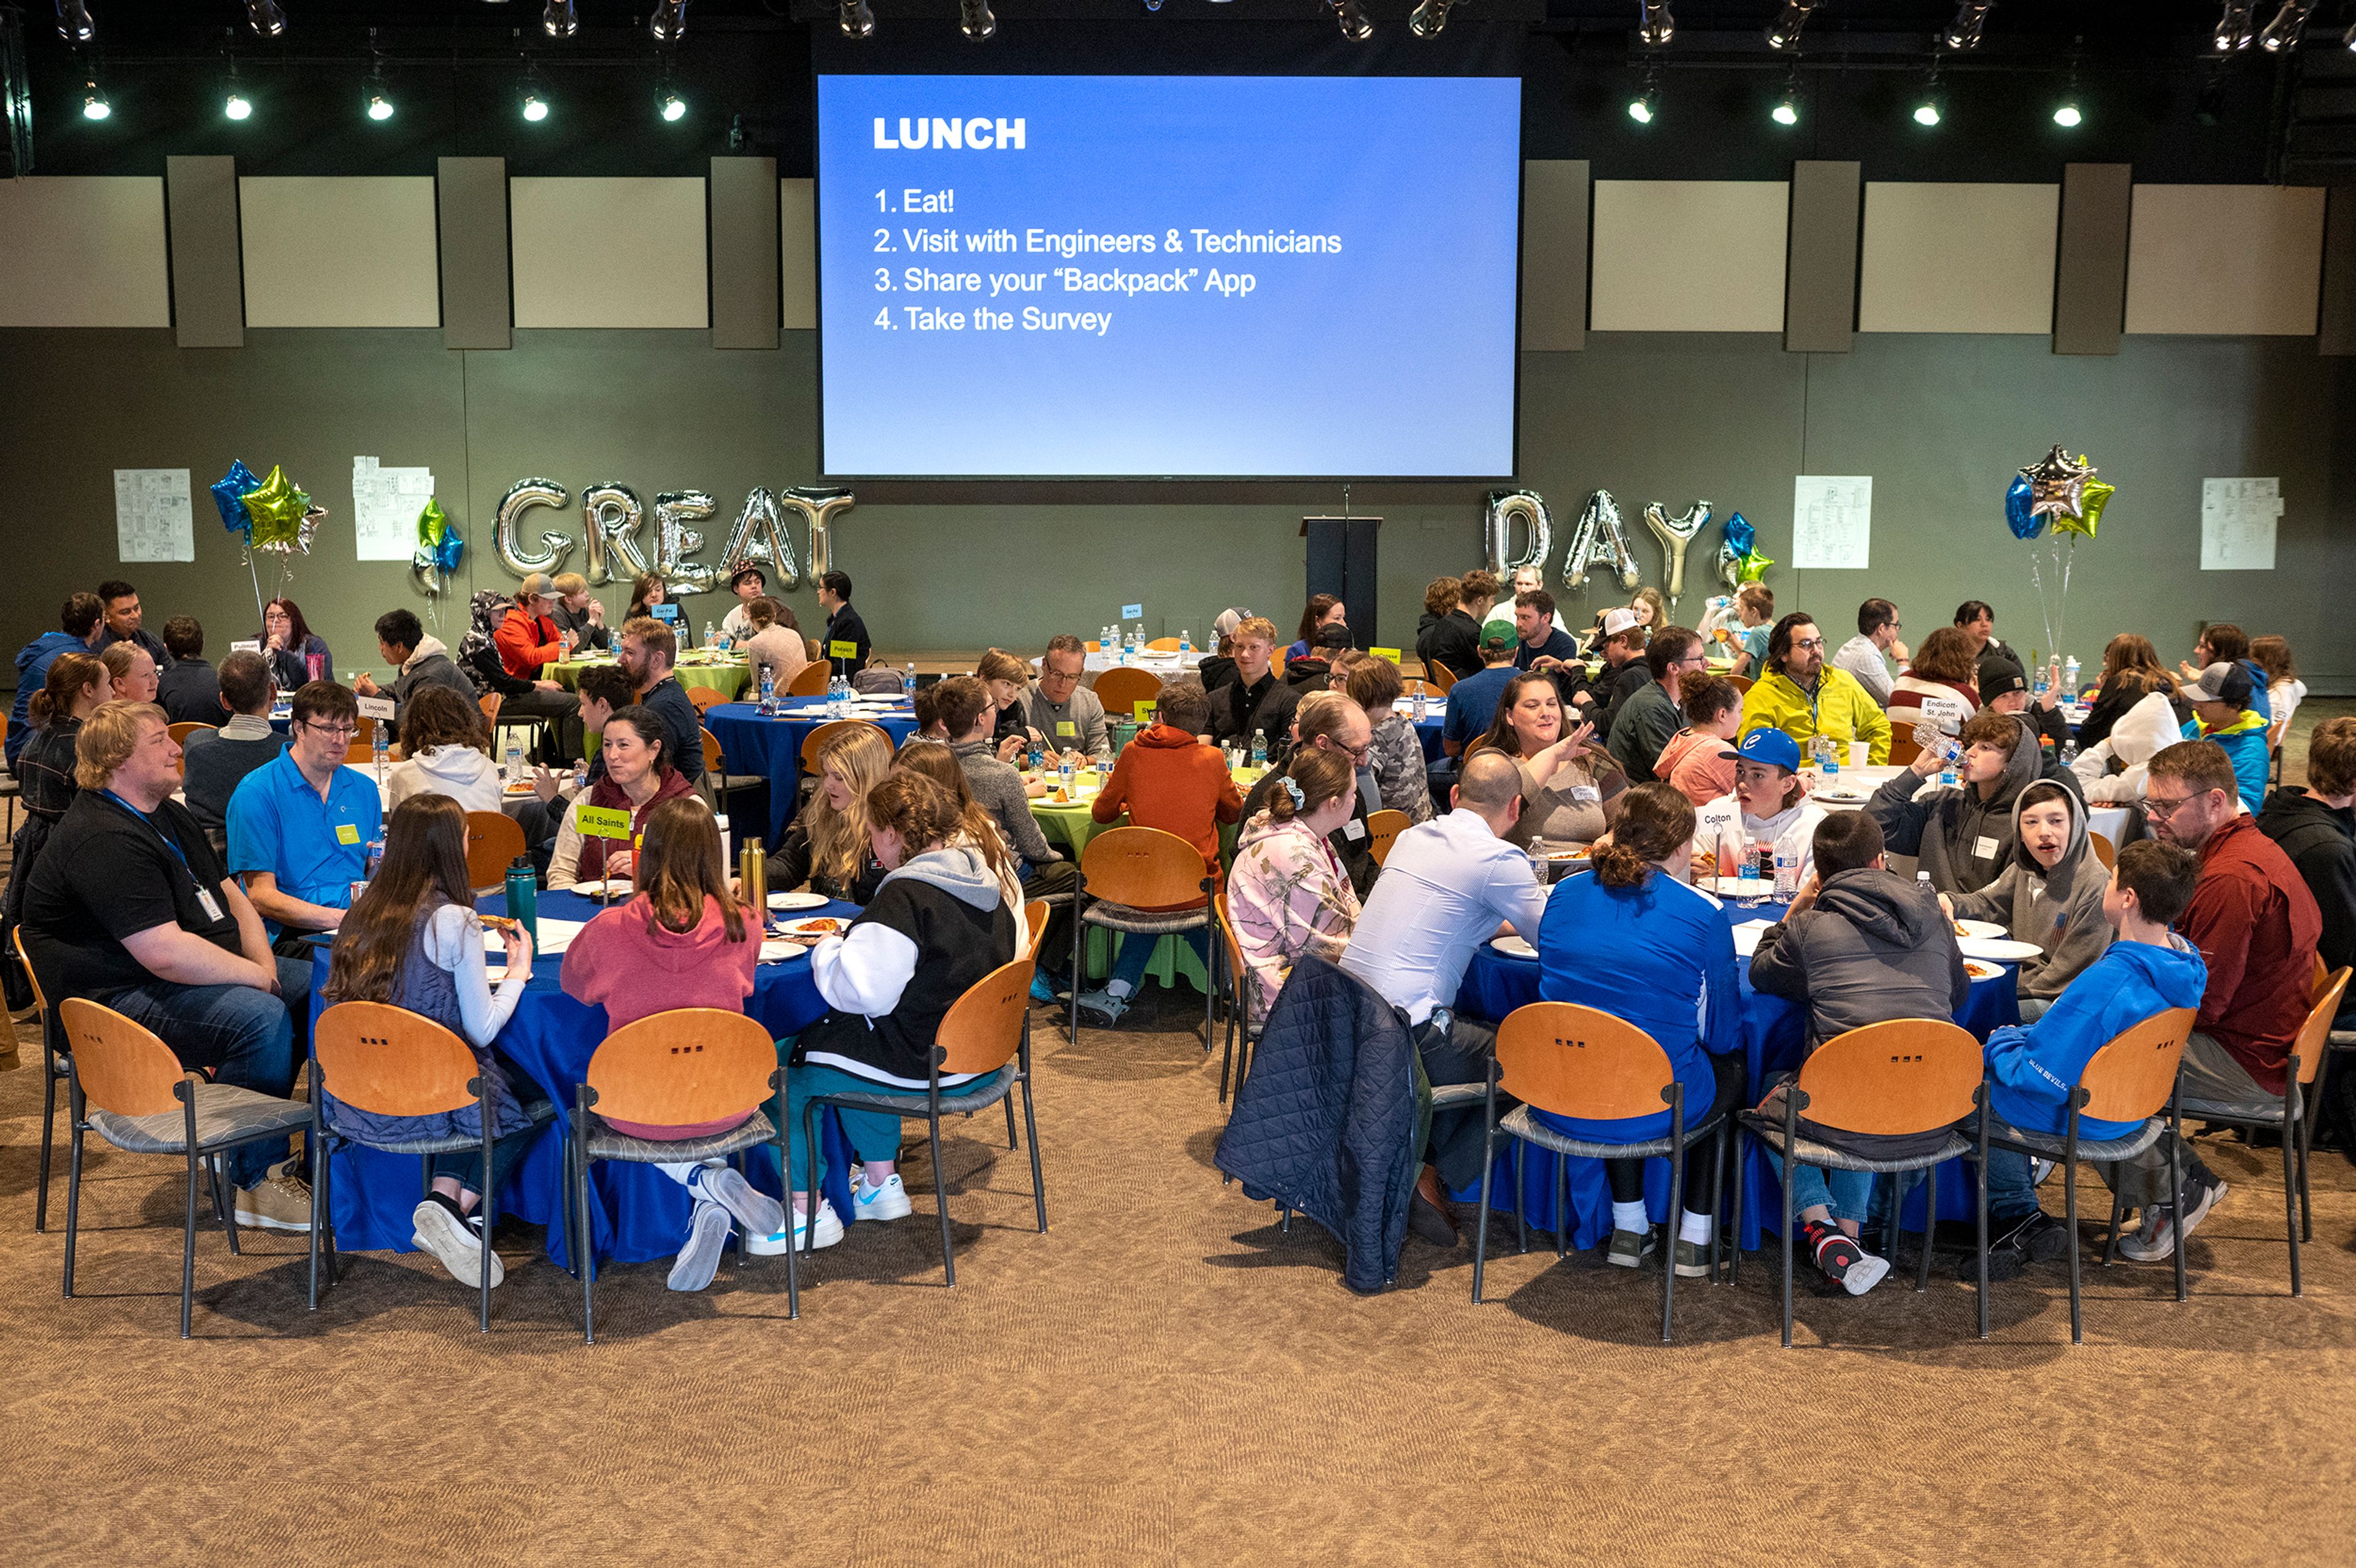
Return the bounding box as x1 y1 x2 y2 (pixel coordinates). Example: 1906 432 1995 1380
311 1007 572 1335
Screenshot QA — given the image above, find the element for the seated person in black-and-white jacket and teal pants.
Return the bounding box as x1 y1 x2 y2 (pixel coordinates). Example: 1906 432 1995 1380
785 772 1023 1248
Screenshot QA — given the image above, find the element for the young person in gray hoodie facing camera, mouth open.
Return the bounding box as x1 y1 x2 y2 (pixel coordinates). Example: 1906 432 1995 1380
1939 779 2111 1024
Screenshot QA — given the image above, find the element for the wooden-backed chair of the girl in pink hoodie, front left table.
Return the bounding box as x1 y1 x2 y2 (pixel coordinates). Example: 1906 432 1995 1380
566 1007 801 1344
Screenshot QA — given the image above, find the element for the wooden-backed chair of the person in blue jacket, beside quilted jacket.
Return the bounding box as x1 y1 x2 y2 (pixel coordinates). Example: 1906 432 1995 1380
1472 1003 1741 1344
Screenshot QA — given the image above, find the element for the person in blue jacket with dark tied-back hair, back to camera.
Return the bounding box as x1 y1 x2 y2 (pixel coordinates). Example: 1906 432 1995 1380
1534 784 1744 1278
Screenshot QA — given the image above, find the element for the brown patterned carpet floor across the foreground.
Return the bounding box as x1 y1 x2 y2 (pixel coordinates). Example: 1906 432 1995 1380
0 711 2356 1568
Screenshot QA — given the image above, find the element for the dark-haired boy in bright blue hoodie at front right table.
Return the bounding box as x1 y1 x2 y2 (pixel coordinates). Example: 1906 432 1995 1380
1965 838 2208 1278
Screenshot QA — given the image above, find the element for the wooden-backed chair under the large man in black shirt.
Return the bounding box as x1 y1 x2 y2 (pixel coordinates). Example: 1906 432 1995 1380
59 996 311 1340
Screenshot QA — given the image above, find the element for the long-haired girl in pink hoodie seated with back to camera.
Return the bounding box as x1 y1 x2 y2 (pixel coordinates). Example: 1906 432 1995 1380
563 796 785 1290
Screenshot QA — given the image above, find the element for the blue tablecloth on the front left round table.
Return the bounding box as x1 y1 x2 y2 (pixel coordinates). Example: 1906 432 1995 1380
311 893 858 1267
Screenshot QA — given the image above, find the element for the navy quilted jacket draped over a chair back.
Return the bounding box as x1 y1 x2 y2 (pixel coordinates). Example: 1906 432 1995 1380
1218 956 1430 1290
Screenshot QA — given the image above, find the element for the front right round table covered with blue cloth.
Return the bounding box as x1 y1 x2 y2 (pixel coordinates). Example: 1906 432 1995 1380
1451 904 2022 1250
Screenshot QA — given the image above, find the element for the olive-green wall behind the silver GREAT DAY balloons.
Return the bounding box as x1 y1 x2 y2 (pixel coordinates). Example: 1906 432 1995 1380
0 329 2356 690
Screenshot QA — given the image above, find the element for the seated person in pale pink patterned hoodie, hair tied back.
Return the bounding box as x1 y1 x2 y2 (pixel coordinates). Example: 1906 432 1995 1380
1228 747 1360 1022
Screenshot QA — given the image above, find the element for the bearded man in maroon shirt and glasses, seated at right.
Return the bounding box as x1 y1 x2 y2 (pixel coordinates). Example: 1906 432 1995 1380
2104 742 2323 1262
